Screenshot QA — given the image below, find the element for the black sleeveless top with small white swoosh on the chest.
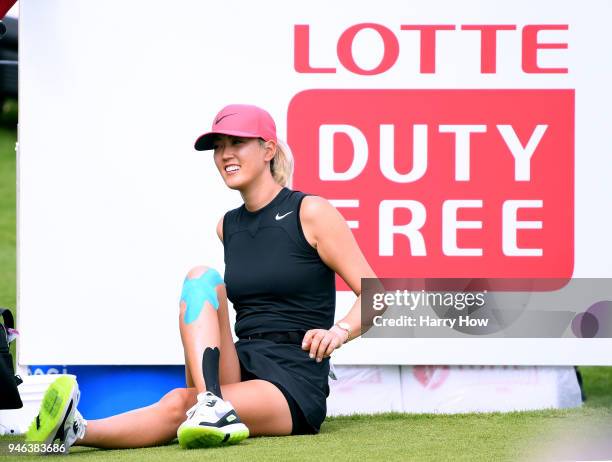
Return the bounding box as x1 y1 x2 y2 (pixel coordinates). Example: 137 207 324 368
223 188 336 338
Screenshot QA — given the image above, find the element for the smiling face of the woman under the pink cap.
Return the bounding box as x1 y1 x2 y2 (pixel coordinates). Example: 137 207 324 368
214 135 274 189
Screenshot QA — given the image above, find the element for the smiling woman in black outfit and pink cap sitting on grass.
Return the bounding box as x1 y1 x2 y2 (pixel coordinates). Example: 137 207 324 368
27 105 375 450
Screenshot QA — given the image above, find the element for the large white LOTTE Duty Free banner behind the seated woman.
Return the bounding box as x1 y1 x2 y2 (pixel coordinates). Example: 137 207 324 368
18 0 612 365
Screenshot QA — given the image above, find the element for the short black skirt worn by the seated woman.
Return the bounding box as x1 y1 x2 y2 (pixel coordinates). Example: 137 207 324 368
236 339 329 435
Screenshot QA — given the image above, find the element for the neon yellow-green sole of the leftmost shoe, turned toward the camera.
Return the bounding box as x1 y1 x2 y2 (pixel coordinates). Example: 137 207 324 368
26 377 79 450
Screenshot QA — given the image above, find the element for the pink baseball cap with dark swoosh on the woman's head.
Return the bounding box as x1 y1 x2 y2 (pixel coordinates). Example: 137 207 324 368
194 104 277 151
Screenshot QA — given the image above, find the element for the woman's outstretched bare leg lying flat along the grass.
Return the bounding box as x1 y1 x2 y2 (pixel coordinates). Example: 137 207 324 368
76 380 292 448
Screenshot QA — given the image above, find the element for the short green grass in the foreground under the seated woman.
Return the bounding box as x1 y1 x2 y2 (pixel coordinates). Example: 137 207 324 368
0 394 612 462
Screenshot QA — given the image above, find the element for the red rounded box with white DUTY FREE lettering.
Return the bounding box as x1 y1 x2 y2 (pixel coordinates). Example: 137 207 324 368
287 90 574 290
